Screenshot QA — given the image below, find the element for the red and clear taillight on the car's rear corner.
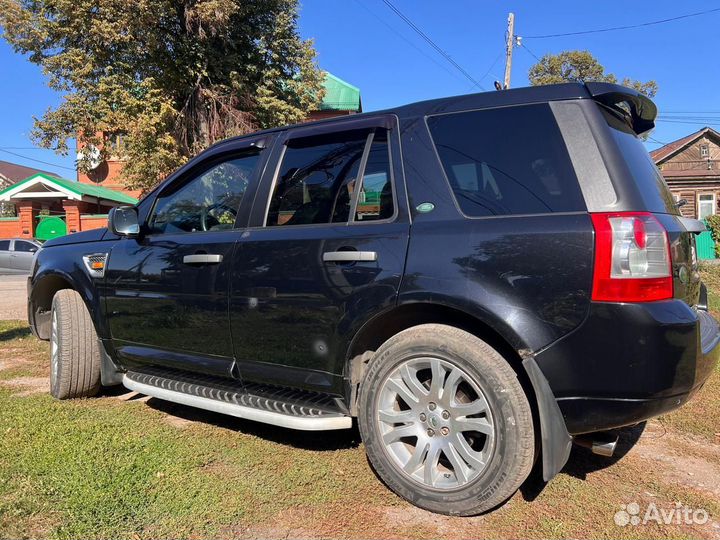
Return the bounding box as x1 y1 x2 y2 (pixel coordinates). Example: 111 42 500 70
591 212 673 302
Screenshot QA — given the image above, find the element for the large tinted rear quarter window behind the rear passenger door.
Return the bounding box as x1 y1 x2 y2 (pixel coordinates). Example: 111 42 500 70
428 104 585 217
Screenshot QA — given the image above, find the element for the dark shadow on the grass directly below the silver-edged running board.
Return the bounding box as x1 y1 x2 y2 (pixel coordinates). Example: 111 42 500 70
147 398 360 451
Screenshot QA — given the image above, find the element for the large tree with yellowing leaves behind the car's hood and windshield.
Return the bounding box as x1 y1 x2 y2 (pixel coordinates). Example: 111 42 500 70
0 0 323 190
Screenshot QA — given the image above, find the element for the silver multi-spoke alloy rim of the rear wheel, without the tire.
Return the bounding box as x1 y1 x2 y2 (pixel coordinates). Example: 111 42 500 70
376 357 495 490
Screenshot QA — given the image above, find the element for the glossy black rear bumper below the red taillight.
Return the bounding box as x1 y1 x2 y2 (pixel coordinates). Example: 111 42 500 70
535 300 720 435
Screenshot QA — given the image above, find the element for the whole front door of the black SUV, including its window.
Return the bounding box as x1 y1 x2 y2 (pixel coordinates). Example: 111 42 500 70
105 140 264 377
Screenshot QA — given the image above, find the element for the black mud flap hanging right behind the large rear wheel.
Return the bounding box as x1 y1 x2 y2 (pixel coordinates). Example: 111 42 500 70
523 356 572 482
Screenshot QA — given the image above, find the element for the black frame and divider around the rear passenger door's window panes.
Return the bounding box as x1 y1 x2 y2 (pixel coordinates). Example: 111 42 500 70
262 122 399 230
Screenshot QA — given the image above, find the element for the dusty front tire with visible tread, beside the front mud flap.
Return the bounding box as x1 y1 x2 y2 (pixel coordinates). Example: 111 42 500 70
50 289 101 399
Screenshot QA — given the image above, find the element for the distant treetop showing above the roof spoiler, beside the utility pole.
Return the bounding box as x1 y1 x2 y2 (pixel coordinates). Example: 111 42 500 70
528 51 658 97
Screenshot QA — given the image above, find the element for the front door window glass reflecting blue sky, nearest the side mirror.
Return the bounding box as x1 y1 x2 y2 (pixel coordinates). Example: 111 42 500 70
150 151 260 233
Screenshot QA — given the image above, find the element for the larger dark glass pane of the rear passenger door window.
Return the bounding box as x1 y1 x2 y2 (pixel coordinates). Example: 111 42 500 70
266 131 368 226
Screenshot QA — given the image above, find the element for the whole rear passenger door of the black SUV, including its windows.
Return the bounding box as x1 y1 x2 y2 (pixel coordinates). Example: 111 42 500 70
230 116 409 393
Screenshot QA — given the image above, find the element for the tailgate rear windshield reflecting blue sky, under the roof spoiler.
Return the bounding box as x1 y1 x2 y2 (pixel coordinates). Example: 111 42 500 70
599 105 680 215
